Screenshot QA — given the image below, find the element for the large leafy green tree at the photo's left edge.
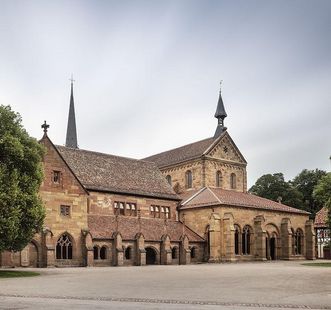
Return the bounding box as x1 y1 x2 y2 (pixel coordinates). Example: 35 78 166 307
0 105 45 252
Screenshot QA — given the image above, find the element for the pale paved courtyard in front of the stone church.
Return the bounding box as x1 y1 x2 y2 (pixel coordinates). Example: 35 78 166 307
0 261 331 310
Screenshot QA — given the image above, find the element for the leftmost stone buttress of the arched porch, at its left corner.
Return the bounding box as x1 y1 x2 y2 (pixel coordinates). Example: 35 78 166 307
208 213 221 263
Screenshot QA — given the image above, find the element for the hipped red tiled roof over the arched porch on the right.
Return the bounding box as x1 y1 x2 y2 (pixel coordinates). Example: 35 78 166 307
180 187 309 214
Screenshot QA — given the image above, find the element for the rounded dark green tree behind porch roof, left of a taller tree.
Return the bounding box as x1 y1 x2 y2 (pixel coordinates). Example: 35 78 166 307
249 173 303 209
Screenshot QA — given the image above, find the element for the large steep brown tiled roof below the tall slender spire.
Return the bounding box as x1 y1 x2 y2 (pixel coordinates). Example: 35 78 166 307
56 146 178 199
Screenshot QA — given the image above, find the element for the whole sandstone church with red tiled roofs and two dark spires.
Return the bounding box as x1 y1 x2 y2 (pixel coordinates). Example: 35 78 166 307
0 83 315 267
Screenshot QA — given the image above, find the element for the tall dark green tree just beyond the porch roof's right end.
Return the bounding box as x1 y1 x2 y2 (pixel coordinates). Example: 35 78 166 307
291 169 326 216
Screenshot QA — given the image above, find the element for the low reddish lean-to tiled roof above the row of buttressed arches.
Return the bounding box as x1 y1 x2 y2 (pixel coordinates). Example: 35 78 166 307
87 215 204 241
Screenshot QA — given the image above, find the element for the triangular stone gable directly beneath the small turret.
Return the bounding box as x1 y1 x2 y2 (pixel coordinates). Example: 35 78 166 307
204 132 247 164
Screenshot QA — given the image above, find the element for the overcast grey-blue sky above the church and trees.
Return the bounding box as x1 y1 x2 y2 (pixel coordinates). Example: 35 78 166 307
0 0 331 186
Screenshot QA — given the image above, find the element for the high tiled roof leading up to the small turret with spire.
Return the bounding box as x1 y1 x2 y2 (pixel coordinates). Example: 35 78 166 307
144 138 215 167
